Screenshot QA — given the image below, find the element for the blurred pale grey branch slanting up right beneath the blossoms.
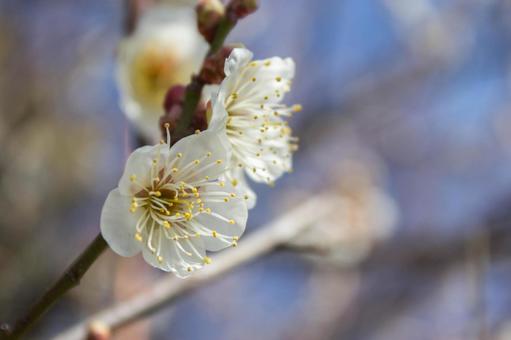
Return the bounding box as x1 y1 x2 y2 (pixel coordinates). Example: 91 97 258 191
55 194 337 340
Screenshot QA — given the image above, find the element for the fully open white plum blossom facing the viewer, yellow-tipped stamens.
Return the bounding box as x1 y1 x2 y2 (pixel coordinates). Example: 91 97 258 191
101 131 247 277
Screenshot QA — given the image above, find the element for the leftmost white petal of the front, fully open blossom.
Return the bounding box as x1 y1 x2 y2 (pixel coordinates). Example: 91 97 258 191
100 189 141 256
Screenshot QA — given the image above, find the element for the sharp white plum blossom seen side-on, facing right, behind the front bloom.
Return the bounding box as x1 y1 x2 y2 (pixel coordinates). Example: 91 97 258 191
209 48 300 208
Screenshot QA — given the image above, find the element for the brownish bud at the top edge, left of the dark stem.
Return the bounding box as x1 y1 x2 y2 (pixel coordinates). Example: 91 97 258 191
195 0 225 42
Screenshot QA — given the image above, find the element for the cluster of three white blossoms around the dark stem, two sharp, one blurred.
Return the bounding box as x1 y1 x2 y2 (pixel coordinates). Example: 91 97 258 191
101 0 300 277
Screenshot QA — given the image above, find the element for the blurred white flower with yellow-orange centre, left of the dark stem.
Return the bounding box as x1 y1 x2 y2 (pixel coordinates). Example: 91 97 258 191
117 5 207 141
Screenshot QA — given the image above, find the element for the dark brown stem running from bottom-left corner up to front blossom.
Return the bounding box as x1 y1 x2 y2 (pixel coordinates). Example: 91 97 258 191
0 234 107 339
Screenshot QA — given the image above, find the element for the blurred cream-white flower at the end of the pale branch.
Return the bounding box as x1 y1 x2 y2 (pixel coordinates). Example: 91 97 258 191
290 160 399 265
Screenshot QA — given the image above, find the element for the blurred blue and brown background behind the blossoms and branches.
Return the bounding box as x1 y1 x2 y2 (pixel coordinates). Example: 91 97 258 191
0 0 511 340
